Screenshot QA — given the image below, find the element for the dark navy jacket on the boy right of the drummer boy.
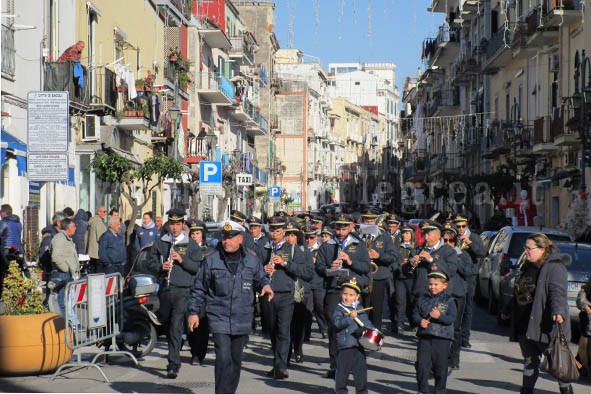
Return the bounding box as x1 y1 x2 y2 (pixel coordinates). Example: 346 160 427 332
412 291 458 339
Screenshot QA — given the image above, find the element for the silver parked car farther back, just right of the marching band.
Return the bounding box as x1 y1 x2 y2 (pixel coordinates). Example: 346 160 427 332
476 226 572 313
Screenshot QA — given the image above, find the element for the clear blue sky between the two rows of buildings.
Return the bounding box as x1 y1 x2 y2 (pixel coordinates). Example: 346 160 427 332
275 0 444 94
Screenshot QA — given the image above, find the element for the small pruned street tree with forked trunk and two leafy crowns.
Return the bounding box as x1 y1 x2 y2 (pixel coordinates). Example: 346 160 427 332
90 151 183 240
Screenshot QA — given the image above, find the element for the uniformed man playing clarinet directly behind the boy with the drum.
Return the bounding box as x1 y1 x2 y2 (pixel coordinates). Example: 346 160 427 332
315 214 371 378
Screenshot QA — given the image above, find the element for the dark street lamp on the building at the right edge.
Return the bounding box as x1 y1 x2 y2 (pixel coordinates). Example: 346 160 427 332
570 49 591 193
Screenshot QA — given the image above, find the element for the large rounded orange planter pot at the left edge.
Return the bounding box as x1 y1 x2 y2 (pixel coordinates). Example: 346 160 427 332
0 313 72 376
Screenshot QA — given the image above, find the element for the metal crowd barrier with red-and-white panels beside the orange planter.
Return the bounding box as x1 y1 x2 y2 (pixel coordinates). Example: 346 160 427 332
51 273 138 382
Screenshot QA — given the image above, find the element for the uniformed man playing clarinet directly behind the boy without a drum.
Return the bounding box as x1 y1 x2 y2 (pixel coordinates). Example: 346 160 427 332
406 220 458 300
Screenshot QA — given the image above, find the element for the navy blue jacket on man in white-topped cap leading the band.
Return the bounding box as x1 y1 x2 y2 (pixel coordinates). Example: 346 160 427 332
187 245 269 335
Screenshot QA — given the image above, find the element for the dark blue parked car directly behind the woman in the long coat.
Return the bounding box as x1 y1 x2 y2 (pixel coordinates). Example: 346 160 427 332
500 242 591 327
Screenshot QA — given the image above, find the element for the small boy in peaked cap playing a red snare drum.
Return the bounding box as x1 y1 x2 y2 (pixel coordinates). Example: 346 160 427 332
332 278 373 394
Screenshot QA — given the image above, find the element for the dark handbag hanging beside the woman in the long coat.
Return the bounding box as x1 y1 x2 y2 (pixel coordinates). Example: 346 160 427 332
542 323 579 383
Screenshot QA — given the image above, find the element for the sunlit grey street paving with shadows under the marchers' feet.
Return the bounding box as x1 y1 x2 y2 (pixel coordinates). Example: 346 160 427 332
0 309 591 394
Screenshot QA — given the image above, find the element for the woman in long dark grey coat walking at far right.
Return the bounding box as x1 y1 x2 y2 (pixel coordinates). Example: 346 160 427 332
504 234 573 394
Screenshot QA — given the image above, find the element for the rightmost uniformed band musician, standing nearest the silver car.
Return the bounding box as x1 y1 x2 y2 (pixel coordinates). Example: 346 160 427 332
453 215 486 348
